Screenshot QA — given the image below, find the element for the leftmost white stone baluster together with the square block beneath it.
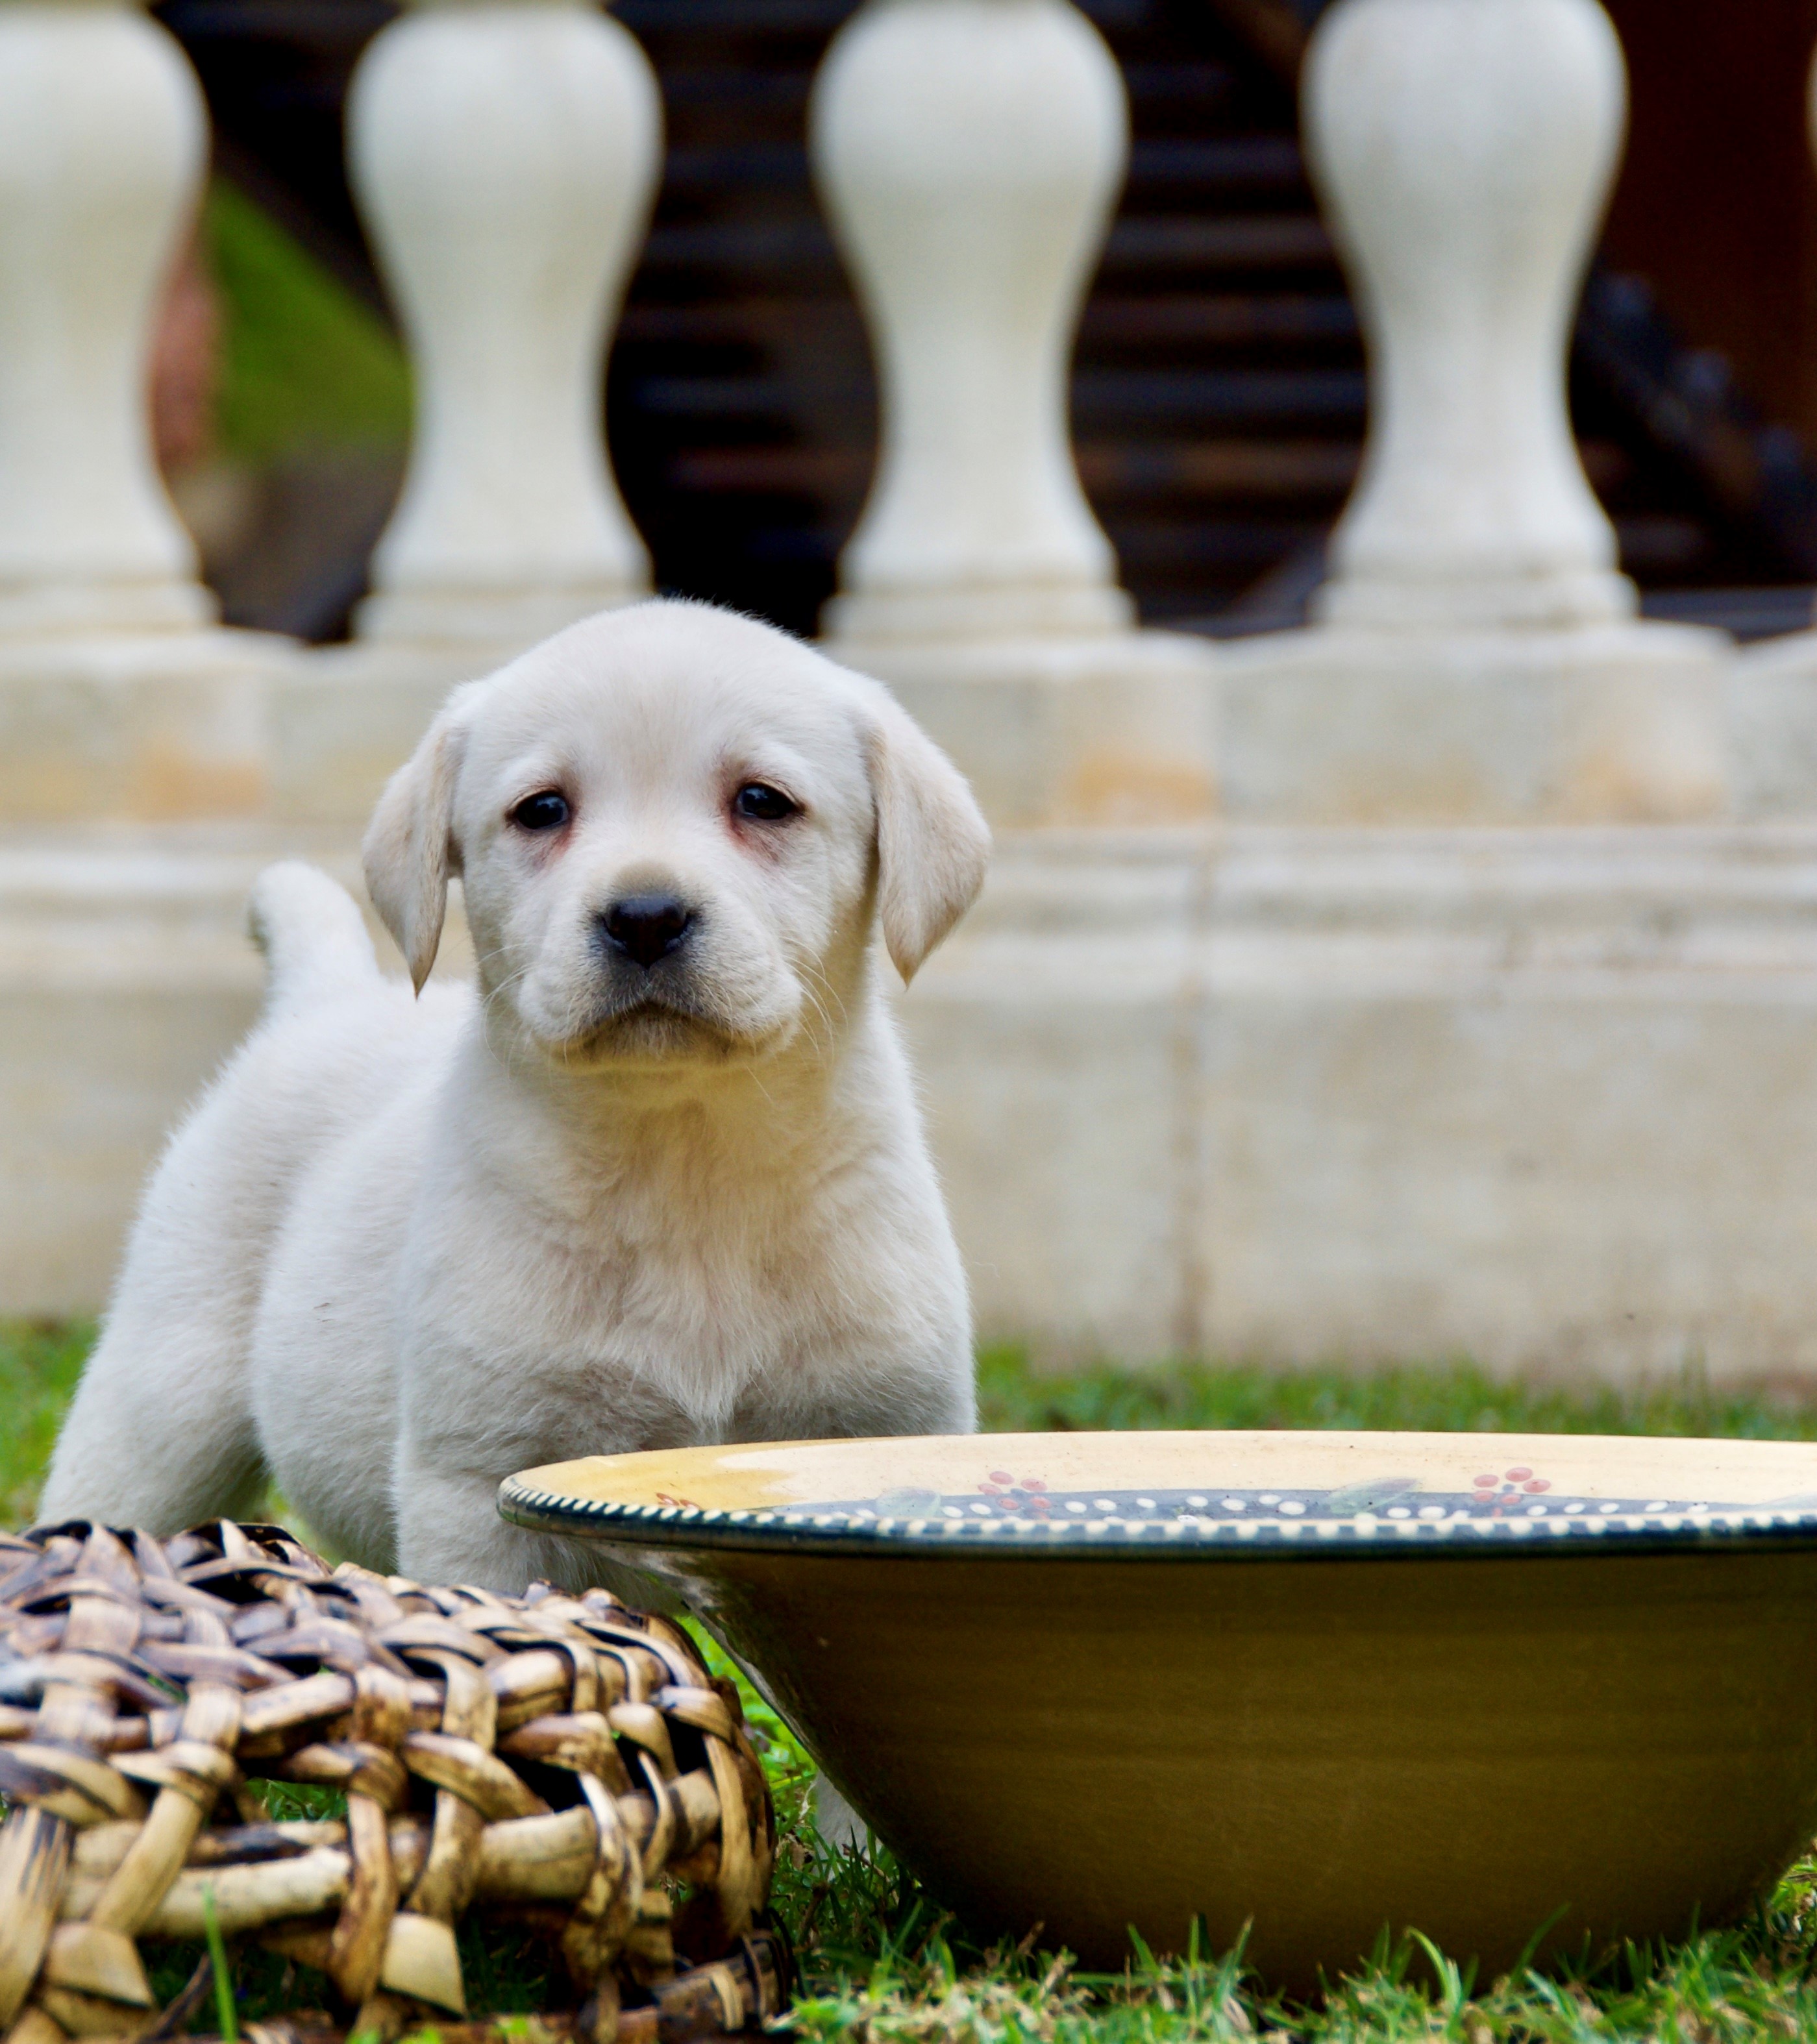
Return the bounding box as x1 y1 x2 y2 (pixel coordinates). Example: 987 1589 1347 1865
0 0 288 824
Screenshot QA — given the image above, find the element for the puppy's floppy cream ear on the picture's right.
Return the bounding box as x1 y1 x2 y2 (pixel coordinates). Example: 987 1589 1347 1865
869 687 991 983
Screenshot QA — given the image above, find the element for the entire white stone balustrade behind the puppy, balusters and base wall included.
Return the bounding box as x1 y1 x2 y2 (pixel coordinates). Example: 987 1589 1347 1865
18 0 1817 1375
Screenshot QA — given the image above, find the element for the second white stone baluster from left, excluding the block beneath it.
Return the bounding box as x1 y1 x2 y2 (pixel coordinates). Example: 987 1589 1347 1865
347 0 662 648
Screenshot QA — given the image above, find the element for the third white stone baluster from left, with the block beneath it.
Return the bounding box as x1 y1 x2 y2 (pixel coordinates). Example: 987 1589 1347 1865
810 0 1212 824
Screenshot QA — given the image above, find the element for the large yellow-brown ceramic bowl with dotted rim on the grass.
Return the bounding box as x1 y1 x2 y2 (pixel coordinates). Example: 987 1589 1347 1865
501 1433 1817 1987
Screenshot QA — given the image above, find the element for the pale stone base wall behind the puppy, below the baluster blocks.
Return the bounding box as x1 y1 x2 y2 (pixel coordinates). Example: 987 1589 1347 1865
0 805 1817 1380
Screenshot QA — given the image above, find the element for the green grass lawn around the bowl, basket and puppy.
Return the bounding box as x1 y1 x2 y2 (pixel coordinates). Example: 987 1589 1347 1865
0 1325 1817 2044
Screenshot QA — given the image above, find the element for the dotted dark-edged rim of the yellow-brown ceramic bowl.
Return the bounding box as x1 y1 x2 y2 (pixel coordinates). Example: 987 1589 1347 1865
499 1429 1817 1562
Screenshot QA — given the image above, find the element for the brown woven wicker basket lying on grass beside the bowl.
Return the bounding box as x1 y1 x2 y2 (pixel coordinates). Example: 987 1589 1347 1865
0 1521 787 2044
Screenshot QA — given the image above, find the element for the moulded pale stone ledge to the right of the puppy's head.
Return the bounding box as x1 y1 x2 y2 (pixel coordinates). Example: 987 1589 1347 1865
944 824 1817 981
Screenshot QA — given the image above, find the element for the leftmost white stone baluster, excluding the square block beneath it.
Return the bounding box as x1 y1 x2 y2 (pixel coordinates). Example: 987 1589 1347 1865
0 0 212 637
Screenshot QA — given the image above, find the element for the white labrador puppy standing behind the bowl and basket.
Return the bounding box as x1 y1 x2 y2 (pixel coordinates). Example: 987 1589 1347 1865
43 603 989 1590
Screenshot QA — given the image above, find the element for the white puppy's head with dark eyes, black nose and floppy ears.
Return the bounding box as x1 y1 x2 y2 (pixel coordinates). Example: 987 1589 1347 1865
366 603 989 1065
